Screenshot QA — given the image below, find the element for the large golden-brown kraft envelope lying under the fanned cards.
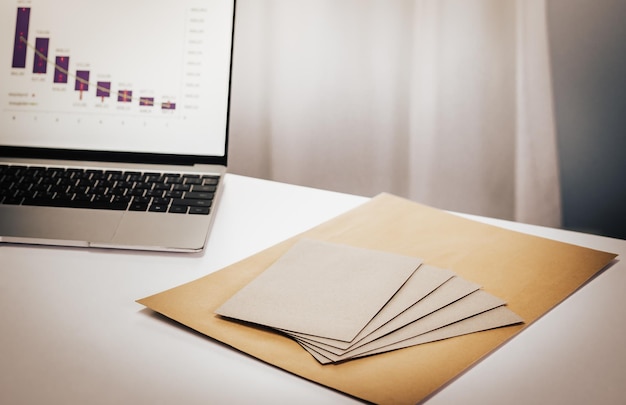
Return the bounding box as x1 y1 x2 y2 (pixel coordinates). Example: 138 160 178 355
138 194 616 404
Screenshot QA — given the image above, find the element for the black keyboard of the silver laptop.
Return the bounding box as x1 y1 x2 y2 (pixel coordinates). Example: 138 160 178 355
0 164 219 215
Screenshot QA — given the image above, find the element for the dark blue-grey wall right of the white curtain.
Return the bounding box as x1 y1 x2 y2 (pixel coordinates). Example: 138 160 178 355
547 0 626 239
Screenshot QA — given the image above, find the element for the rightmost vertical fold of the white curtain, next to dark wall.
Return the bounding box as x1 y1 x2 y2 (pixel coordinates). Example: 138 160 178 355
514 0 562 227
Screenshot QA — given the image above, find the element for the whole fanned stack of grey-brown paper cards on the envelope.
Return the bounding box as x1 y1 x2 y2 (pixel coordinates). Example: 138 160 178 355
216 239 522 364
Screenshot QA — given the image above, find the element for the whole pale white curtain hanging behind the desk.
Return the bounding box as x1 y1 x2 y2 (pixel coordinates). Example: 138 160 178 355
230 0 561 226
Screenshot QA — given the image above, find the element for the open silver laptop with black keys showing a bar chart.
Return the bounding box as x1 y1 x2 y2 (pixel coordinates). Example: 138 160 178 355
0 0 235 252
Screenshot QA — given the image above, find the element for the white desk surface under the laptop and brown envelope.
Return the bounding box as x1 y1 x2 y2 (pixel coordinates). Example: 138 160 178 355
0 174 626 404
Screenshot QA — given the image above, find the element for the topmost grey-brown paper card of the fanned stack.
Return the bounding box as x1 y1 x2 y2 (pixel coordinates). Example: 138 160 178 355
215 239 422 342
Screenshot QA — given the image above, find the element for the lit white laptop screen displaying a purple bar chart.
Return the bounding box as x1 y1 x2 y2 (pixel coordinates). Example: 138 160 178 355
0 0 234 163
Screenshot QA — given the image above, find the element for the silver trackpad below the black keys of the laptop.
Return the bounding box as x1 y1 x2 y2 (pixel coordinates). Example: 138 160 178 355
0 205 124 246
